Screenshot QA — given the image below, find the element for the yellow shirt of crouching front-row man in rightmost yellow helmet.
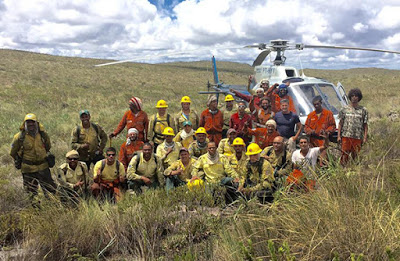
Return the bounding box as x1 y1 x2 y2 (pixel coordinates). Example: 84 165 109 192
243 160 275 191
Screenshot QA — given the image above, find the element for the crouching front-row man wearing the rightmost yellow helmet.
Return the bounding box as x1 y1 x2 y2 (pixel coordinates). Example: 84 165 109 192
238 143 274 203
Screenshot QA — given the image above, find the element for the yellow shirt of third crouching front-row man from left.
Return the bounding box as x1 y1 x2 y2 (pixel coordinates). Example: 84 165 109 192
127 153 164 186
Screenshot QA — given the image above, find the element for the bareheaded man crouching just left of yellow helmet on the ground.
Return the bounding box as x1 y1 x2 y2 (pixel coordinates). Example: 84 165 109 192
164 148 196 191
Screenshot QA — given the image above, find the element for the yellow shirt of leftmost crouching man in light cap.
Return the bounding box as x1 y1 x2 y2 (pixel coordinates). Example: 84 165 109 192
58 161 89 189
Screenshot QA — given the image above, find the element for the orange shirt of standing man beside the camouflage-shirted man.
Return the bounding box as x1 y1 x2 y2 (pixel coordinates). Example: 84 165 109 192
304 106 336 146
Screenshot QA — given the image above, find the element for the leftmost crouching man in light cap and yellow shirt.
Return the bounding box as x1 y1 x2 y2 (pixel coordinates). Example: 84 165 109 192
57 150 89 201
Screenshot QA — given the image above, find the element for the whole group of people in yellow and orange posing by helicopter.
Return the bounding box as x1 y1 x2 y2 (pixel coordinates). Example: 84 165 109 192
10 77 368 202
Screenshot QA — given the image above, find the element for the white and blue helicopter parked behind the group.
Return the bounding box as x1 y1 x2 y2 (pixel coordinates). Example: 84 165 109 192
199 39 400 126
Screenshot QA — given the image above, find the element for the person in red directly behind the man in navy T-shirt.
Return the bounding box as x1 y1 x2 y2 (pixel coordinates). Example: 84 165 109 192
266 82 297 113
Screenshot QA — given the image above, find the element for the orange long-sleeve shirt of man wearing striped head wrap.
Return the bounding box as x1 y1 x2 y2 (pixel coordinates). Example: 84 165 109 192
114 110 149 141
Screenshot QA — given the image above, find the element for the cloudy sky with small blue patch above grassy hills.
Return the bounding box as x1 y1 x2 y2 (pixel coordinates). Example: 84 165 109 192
0 0 400 69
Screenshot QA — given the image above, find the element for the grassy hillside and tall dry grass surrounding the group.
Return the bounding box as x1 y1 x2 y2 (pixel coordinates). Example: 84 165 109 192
0 50 400 260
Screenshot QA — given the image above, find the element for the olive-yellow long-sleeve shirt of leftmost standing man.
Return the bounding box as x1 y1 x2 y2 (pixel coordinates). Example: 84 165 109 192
10 125 50 173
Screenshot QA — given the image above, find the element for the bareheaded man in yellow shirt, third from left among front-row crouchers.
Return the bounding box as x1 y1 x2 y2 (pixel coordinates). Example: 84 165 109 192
127 142 165 194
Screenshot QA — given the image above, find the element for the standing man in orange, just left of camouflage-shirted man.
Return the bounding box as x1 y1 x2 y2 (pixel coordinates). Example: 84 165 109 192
304 95 336 166
